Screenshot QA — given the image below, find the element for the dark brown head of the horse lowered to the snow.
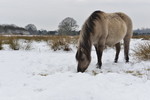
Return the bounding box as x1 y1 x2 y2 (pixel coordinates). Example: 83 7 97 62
76 48 91 72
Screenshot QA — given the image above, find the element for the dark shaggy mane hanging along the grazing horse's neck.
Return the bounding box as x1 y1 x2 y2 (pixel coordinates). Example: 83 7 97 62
79 11 104 57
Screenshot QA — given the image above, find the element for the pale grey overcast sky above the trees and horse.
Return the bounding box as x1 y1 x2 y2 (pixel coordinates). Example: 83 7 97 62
0 0 150 30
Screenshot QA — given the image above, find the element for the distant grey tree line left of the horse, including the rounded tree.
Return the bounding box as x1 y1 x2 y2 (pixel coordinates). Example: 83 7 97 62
0 17 79 35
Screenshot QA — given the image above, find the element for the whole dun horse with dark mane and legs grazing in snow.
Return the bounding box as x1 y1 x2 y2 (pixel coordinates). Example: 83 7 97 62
76 11 133 72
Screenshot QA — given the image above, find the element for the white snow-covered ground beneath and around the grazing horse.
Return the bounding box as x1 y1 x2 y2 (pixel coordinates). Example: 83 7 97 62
0 39 150 100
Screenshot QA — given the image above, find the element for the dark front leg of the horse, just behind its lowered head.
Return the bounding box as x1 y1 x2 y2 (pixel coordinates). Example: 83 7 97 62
95 46 104 69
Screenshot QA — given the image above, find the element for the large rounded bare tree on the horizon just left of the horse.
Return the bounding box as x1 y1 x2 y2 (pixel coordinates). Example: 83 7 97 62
58 17 78 35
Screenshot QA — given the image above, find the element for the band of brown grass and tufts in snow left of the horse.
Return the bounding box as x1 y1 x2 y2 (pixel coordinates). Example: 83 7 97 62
0 35 78 51
